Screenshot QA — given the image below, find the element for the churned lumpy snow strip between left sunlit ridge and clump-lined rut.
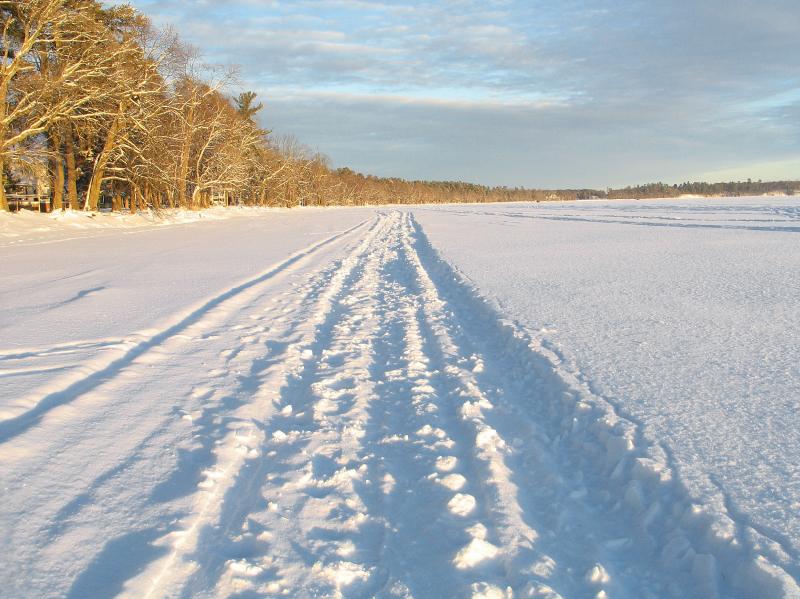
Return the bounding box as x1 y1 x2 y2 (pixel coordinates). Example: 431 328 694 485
196 217 392 595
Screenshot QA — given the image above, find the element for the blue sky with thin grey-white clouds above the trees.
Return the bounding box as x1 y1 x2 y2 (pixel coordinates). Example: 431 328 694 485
132 0 800 188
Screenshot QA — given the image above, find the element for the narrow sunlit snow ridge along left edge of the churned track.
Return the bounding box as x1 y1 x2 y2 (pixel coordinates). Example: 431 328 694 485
126 213 396 596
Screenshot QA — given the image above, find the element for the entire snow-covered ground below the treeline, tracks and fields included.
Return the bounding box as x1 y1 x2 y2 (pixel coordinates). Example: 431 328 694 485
0 203 800 597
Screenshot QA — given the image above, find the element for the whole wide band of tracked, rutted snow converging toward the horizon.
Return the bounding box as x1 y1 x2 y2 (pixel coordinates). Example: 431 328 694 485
0 205 800 598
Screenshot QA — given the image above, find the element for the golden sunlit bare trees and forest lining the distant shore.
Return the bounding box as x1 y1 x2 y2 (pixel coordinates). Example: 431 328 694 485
0 0 800 212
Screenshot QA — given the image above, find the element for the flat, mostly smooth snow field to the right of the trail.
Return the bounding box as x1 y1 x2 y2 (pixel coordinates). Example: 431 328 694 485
415 198 800 596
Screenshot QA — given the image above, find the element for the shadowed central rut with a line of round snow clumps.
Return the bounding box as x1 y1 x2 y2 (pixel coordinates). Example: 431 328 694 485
356 213 524 596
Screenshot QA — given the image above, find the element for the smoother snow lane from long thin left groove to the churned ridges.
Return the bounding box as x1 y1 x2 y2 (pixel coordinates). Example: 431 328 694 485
0 220 378 596
